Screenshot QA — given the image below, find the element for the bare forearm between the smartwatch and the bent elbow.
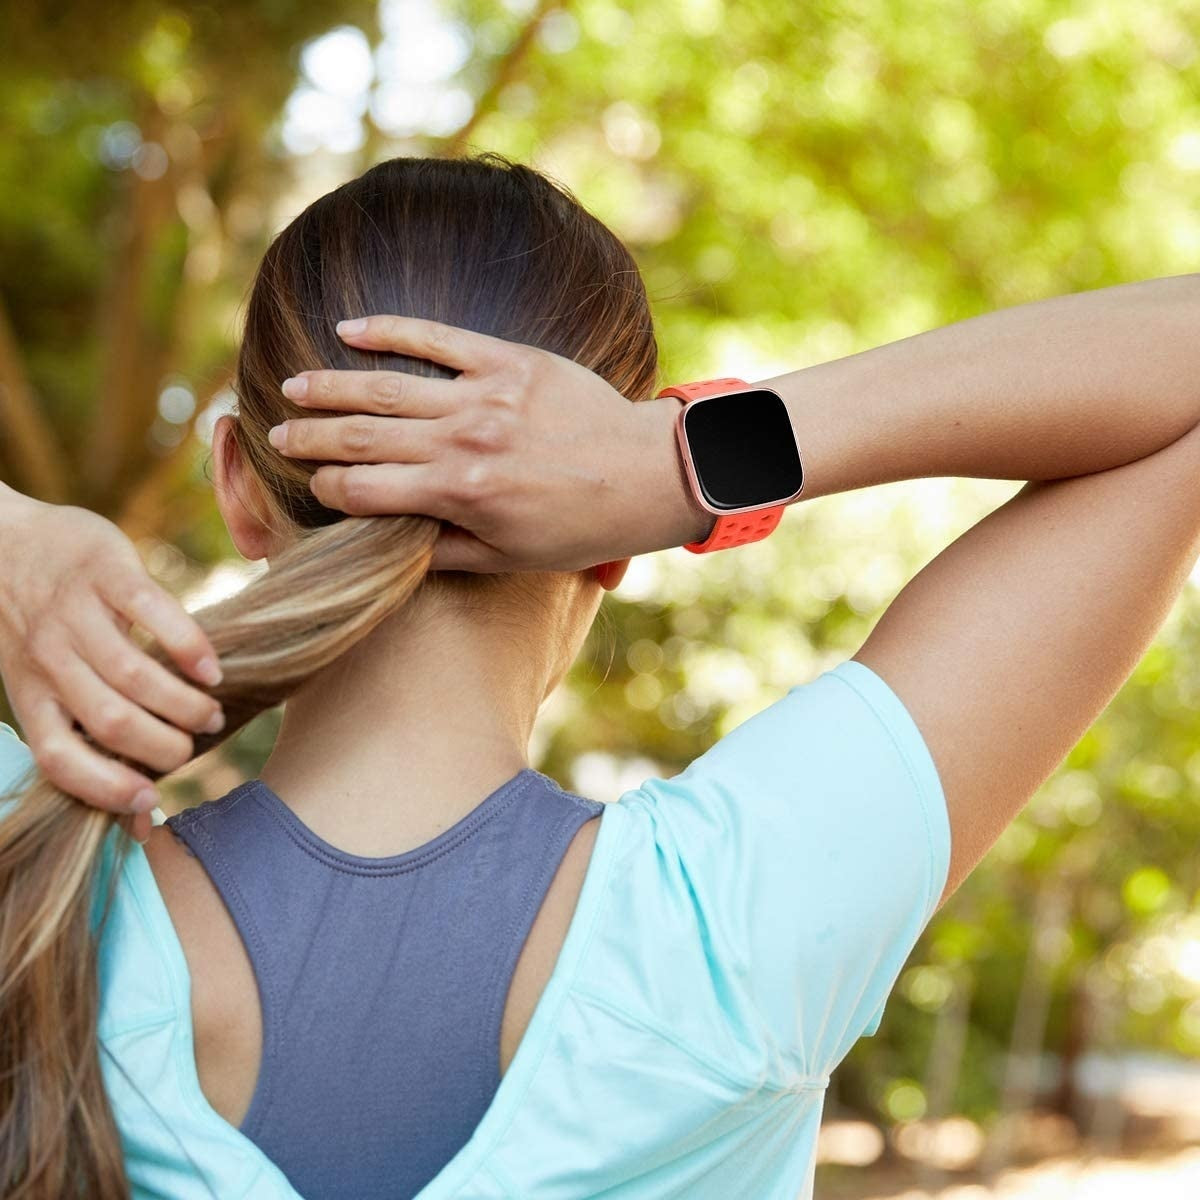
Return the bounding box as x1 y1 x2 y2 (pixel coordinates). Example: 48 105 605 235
761 275 1200 499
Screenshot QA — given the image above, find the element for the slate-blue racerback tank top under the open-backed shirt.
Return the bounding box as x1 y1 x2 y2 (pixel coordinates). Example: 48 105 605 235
167 767 604 1200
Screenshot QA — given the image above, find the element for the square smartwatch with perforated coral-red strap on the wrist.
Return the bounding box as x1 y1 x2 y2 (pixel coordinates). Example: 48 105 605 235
659 378 804 554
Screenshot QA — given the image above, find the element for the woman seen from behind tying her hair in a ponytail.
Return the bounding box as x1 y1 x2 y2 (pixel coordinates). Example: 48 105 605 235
0 157 1200 1200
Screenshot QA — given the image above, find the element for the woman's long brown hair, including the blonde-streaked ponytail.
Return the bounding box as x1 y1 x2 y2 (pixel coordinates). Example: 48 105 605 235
0 154 658 1200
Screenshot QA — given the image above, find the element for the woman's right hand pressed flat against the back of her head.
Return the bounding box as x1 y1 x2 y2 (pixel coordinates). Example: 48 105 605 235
271 317 713 571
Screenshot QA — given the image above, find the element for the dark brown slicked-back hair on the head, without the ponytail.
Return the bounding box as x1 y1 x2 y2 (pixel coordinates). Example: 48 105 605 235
236 155 658 528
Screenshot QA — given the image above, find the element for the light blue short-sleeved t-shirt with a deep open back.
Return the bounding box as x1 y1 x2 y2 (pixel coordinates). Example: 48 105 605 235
0 660 949 1200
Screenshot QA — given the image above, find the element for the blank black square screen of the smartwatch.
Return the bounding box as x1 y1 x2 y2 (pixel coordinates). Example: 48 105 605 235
683 388 804 509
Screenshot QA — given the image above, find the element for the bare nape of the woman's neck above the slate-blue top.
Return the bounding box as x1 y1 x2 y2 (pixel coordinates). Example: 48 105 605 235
260 597 553 857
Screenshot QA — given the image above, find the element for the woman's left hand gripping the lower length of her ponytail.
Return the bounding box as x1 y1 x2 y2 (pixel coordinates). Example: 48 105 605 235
0 486 223 838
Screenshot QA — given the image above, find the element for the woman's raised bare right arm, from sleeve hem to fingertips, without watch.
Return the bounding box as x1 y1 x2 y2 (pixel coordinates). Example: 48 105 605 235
277 275 1200 893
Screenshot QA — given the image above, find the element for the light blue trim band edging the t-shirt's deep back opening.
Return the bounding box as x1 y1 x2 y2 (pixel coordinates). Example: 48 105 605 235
122 787 630 1200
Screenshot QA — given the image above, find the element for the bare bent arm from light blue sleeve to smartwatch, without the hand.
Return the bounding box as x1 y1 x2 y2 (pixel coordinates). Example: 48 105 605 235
767 275 1200 894
